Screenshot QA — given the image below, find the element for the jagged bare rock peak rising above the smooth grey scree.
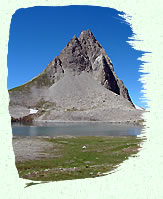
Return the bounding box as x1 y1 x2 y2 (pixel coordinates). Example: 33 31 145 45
40 30 131 102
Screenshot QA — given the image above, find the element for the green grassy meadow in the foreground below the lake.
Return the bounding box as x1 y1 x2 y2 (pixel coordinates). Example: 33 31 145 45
16 136 143 182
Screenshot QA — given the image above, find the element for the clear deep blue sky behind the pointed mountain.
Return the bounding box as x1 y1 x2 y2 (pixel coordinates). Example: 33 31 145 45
8 6 146 107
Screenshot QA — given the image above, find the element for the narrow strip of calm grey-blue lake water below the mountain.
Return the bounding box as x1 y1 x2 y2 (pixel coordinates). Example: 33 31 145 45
12 122 142 136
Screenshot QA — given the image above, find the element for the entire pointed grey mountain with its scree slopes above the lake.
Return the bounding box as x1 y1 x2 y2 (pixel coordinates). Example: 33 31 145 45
9 30 142 123
